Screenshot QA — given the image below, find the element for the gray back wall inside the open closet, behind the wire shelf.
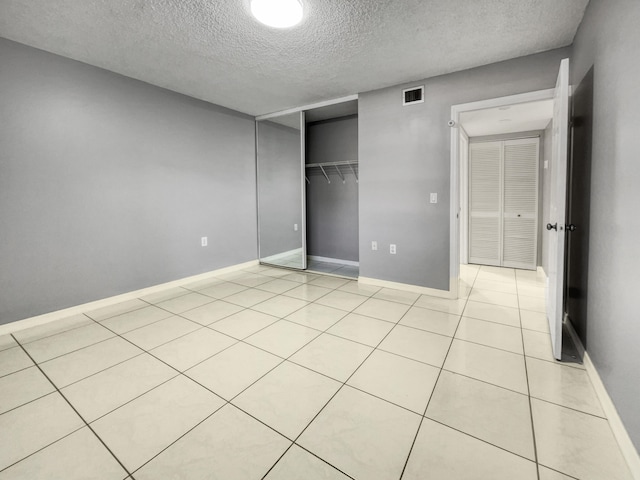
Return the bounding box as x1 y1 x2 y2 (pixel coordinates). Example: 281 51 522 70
306 116 358 262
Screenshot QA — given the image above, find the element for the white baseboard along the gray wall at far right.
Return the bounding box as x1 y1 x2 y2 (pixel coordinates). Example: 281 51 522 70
565 314 640 480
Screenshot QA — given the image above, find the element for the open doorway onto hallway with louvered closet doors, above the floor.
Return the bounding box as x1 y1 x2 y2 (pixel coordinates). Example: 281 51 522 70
457 99 553 270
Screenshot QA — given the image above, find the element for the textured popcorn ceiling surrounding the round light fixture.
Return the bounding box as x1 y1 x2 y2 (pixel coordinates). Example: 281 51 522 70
0 0 588 115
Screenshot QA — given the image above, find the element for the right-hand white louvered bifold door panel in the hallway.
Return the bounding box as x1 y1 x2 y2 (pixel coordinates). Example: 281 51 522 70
502 138 539 270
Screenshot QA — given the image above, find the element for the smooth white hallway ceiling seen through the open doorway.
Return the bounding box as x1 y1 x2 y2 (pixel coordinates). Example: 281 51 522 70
460 100 553 137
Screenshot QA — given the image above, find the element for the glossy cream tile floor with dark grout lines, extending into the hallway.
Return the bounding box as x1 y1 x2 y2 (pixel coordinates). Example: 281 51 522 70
0 266 631 480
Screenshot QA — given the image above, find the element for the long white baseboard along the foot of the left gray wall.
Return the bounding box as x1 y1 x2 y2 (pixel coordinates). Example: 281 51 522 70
0 260 258 335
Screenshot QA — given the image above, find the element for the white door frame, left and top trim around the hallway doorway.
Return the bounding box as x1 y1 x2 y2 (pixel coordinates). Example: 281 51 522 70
449 88 555 291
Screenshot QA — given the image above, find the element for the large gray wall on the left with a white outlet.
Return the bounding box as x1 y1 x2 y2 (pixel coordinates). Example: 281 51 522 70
0 39 257 323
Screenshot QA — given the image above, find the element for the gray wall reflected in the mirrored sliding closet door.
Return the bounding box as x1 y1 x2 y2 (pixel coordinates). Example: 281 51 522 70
258 117 303 258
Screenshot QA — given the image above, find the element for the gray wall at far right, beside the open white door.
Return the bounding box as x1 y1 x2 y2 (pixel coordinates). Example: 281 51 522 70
571 0 640 448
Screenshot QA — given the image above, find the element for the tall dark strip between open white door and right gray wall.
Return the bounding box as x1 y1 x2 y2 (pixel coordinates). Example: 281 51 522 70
565 67 593 348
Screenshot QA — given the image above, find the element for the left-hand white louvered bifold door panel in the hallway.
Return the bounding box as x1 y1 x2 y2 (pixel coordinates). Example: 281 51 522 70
469 142 502 265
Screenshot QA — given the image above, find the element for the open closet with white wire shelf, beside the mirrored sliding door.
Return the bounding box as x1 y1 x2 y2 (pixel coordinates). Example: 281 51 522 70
305 100 359 278
